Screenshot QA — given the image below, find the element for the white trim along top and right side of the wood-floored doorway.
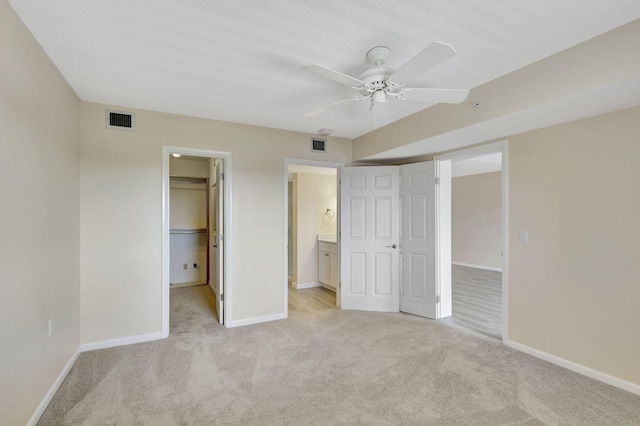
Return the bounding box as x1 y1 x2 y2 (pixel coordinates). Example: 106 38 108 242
433 140 509 344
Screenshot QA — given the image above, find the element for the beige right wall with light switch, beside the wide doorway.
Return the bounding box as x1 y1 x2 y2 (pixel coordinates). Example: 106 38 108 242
509 108 640 384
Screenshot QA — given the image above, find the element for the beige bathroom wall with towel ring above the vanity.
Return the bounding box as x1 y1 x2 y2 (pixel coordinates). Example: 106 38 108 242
293 173 338 284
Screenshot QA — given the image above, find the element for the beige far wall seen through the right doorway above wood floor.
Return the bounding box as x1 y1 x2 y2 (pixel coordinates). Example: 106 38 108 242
451 171 502 269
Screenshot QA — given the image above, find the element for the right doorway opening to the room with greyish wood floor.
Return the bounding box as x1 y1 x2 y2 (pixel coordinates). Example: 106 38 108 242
435 141 508 341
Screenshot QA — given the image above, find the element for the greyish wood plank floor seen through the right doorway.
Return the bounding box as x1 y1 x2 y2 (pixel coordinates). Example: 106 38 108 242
451 265 502 336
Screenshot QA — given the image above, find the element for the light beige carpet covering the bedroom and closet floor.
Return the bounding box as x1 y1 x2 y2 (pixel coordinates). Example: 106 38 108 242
39 286 640 425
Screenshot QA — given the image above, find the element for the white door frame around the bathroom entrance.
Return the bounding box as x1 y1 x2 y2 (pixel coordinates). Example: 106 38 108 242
282 158 344 318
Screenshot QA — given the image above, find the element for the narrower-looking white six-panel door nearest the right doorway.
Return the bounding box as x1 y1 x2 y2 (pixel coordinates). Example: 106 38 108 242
400 161 437 319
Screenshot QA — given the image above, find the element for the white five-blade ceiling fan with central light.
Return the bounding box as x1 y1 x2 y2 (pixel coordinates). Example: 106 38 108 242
303 42 469 127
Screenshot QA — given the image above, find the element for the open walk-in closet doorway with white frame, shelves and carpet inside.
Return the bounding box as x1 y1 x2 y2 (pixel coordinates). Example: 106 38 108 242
162 147 231 337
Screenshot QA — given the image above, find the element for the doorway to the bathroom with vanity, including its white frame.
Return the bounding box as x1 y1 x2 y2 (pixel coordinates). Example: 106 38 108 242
284 159 341 315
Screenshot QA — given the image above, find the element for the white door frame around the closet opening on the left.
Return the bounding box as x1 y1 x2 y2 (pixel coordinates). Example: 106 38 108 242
161 145 233 338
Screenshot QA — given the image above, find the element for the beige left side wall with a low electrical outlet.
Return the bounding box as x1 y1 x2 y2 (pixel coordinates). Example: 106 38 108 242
0 0 80 425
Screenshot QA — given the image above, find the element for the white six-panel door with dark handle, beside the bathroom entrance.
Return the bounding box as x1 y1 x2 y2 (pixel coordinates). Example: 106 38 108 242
340 166 400 312
